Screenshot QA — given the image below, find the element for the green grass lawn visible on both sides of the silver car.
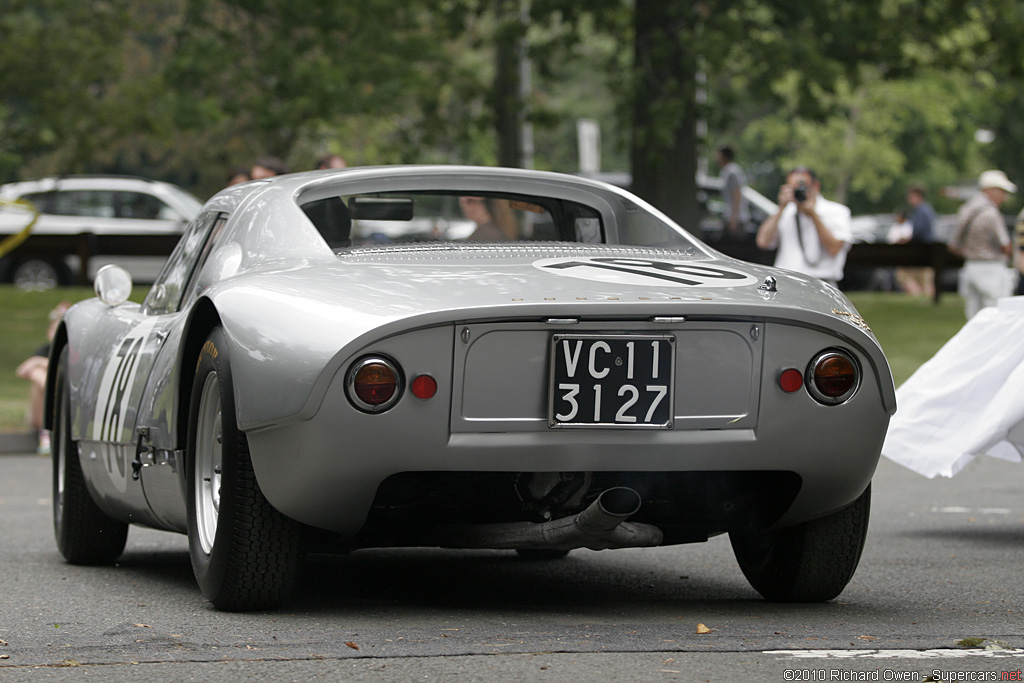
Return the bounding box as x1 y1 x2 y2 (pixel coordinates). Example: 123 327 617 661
0 285 965 432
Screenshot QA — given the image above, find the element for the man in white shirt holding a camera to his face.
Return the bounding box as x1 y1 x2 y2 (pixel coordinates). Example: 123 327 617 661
757 167 853 285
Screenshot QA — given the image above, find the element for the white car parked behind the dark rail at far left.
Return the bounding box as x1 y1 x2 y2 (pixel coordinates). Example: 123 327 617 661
0 175 203 289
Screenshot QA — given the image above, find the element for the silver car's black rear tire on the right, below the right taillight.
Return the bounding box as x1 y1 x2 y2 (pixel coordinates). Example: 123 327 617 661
729 484 871 602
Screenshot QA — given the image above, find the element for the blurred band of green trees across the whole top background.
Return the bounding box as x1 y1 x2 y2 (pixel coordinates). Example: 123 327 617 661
0 0 1024 219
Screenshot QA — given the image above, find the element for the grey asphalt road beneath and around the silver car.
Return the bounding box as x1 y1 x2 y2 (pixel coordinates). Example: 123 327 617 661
0 456 1024 683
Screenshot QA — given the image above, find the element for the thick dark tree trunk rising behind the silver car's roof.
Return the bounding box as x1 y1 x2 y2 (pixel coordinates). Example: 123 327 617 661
631 1 699 231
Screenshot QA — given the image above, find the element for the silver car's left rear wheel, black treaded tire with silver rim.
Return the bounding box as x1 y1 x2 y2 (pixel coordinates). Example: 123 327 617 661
186 328 301 611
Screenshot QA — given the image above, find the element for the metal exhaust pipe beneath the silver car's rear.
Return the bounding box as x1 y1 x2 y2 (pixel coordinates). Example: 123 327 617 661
438 486 665 550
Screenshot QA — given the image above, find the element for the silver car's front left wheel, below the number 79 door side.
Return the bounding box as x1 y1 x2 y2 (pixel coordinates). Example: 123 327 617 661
52 347 128 565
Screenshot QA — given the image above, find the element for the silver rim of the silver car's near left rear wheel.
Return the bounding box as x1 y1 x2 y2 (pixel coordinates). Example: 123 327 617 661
193 373 223 555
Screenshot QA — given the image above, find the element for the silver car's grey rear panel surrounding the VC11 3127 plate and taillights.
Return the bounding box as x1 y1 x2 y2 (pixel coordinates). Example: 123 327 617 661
248 322 889 537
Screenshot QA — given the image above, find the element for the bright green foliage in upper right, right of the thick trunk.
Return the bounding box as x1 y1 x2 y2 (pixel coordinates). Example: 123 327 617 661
710 0 1024 212
